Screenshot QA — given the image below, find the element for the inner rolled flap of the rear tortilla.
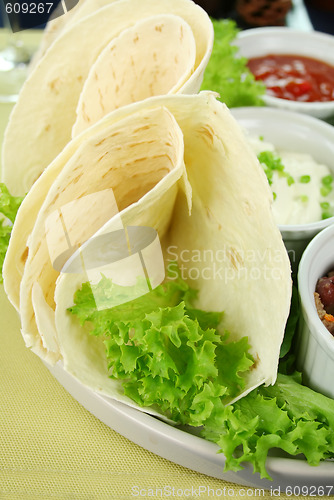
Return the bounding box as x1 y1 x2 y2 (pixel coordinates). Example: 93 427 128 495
72 14 196 137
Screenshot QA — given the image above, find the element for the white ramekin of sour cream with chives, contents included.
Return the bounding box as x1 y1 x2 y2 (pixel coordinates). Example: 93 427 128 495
231 107 334 271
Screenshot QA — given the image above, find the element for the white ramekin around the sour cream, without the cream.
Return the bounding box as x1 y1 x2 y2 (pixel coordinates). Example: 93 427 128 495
231 106 334 271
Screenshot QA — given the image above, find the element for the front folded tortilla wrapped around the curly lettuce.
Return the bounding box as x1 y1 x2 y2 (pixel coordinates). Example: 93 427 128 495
4 92 291 406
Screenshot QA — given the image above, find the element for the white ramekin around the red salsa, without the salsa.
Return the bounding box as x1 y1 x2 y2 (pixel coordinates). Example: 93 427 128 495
234 27 334 118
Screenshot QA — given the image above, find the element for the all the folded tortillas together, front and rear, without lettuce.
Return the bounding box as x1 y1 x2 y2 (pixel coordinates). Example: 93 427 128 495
3 0 291 414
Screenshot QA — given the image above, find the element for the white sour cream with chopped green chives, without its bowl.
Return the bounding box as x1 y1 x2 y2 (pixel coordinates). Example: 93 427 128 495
248 136 334 225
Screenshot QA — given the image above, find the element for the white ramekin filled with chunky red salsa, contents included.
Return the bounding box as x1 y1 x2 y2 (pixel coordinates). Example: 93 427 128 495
235 27 334 118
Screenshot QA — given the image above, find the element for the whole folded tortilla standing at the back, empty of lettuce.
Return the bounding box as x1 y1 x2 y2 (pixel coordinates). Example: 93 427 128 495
2 0 213 195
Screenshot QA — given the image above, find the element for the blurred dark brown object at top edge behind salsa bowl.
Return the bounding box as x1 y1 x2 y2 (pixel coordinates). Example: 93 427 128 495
236 0 292 27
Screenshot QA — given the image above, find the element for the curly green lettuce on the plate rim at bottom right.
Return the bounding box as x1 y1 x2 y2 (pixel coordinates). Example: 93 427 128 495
202 373 334 479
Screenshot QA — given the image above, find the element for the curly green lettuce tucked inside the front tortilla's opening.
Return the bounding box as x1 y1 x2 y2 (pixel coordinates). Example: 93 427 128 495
70 270 253 427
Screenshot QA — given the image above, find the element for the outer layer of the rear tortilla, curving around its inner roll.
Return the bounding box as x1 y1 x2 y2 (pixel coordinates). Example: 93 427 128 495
2 0 213 195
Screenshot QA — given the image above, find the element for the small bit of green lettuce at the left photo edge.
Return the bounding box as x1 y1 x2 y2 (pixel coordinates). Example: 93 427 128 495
0 183 23 283
